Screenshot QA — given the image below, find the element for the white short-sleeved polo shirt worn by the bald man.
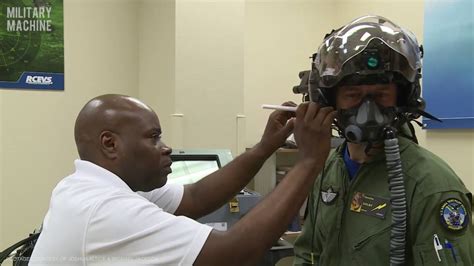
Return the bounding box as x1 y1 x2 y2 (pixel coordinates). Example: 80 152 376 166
29 160 212 265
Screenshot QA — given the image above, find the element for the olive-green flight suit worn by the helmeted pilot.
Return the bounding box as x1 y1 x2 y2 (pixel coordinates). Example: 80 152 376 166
294 138 474 266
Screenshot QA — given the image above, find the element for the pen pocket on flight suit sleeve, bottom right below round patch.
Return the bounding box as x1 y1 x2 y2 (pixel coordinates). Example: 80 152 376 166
413 243 464 266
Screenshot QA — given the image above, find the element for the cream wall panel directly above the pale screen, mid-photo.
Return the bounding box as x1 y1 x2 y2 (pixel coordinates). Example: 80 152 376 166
175 0 244 155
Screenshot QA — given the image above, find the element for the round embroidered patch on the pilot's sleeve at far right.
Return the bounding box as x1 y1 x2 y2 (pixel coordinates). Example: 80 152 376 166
439 199 469 232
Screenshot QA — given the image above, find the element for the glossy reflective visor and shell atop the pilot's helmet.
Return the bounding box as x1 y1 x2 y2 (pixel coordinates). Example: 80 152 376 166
314 16 421 87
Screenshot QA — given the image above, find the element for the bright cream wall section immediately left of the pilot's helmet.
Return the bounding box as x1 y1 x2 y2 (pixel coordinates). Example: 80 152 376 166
244 0 335 147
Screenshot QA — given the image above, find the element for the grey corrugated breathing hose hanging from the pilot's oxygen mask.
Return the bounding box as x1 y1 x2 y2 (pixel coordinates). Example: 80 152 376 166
384 127 407 266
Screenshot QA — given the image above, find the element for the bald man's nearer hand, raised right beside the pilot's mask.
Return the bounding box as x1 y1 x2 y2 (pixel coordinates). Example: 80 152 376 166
294 102 337 166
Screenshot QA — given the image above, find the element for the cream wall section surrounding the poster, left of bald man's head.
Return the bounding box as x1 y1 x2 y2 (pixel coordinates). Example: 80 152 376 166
0 0 138 249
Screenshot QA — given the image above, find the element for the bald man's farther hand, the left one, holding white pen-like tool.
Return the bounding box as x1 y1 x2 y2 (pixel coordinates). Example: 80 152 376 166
259 102 296 155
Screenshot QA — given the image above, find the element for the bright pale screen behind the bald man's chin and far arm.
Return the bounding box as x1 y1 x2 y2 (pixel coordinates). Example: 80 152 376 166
168 149 232 185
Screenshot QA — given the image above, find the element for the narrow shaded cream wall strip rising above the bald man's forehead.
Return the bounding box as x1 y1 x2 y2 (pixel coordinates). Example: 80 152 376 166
138 0 176 145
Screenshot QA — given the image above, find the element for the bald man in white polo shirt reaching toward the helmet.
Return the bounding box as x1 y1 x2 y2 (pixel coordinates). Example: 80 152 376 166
30 95 335 265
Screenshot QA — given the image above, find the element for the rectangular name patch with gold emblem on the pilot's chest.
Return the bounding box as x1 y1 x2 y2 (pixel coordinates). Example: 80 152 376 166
351 192 389 219
